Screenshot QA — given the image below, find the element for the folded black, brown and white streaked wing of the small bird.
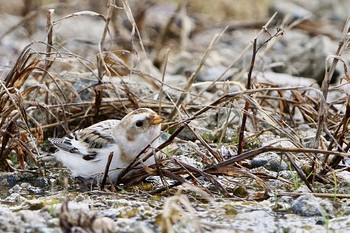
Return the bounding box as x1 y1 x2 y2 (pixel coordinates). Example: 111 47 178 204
49 120 119 160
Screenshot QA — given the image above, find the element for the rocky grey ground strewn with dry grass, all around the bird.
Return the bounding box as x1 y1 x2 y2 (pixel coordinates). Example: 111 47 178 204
0 0 350 232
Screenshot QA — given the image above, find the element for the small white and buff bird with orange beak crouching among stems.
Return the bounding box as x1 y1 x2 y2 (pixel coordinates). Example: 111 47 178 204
49 108 163 180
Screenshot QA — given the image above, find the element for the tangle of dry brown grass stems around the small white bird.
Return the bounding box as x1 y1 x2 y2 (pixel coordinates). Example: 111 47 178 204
0 1 350 204
